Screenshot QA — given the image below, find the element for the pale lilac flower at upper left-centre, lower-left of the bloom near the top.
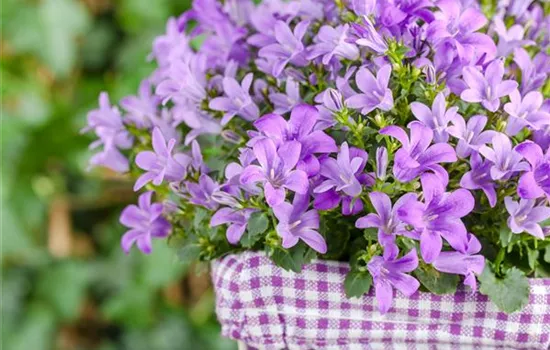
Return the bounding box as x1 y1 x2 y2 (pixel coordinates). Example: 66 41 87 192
209 73 260 125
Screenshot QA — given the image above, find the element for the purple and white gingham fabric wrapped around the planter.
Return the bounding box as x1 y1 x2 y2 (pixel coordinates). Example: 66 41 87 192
212 252 550 350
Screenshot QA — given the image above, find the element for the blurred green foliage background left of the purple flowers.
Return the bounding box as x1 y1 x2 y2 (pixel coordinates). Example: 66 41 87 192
0 0 236 350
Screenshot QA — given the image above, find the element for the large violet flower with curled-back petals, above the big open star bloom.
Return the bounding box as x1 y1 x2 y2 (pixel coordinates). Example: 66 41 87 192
380 122 457 182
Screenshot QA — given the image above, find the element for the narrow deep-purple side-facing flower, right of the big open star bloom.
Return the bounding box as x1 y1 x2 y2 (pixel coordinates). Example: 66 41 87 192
460 152 497 208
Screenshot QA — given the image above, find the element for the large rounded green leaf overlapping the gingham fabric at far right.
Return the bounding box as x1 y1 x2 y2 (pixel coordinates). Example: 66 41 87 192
479 266 529 313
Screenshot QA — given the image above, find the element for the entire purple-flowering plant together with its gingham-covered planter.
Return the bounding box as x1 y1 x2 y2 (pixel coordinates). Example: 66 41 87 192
86 0 550 349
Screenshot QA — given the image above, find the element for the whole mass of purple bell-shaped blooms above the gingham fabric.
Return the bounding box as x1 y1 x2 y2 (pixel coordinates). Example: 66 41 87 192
86 0 550 312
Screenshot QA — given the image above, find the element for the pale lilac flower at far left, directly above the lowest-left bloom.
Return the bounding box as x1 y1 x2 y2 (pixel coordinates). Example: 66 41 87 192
134 128 191 191
